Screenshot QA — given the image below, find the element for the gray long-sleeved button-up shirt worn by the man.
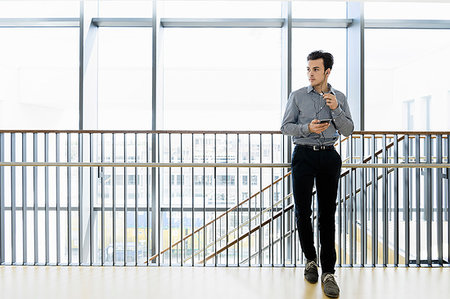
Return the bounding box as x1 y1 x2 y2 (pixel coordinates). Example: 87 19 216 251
281 84 353 145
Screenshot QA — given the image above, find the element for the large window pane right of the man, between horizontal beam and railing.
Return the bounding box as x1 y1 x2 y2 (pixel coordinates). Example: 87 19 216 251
365 29 450 130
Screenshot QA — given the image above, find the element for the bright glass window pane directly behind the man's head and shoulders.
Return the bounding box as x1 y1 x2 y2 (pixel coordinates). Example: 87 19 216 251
292 28 347 94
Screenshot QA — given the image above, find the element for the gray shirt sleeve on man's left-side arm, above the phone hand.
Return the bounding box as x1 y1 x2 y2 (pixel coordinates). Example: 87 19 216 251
280 93 311 137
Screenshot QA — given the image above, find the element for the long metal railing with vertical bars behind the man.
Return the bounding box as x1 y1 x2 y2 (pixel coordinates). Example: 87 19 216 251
0 131 450 266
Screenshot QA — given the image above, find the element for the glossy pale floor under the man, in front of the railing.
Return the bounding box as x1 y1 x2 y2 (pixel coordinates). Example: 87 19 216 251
0 266 450 299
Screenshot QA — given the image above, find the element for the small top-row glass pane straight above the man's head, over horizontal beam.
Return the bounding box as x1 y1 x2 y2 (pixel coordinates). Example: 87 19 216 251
292 1 347 19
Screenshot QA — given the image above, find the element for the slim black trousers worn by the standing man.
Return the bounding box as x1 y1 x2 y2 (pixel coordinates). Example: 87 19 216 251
292 145 342 273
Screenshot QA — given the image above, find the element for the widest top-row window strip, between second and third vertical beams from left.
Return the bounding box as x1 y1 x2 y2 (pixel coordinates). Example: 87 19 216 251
163 1 281 18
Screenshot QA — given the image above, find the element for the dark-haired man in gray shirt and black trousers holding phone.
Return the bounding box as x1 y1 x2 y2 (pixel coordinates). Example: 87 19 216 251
281 51 353 298
